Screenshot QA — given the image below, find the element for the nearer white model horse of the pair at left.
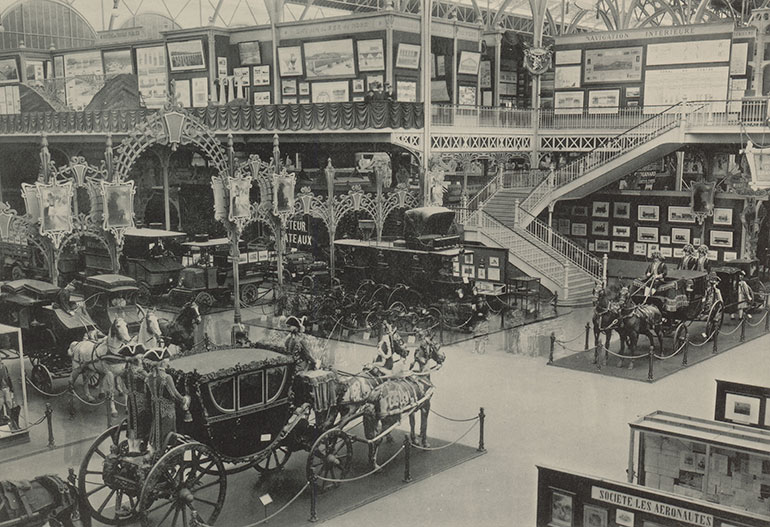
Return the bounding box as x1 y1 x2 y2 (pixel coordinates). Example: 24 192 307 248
67 317 131 417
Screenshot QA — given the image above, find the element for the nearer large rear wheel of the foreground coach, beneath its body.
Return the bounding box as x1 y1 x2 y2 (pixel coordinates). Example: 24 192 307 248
138 443 227 527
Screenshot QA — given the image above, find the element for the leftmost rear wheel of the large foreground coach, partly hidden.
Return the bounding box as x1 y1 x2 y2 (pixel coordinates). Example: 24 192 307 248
78 421 139 525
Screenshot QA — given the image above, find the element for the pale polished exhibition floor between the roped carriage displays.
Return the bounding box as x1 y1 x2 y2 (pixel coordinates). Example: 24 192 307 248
0 311 770 527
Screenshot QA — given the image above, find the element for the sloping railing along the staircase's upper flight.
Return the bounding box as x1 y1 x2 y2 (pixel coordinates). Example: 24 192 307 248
521 102 683 217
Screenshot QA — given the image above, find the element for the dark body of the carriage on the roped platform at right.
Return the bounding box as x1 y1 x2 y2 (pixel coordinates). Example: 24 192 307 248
634 269 708 321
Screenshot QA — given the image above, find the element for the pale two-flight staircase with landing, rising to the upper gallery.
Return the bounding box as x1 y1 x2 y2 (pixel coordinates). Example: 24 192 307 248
462 103 700 305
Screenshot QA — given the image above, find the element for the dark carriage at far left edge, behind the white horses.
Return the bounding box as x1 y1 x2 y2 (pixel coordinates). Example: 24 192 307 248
0 279 94 393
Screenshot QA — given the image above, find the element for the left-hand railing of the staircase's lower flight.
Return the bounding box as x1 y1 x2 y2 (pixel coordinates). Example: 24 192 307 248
469 210 566 287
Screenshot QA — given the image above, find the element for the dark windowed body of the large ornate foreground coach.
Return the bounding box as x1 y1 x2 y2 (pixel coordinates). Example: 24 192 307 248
169 348 294 458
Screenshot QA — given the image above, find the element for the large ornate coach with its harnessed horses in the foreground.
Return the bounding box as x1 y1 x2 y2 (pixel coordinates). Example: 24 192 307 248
78 334 443 527
